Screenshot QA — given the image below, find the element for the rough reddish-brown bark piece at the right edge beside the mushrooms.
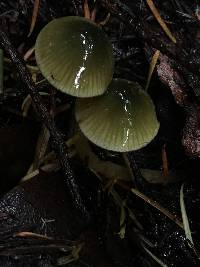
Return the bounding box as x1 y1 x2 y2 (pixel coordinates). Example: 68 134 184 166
157 55 200 157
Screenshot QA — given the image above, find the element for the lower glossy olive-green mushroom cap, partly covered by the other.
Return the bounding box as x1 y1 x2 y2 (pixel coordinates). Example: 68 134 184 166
75 79 159 152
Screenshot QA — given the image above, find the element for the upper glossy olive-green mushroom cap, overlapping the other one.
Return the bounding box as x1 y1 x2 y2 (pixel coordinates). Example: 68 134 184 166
35 16 114 97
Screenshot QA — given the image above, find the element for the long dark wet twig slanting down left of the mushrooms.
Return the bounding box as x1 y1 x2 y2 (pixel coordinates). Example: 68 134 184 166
0 28 89 222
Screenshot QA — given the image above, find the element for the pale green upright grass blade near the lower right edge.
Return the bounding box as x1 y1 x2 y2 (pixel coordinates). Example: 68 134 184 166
180 184 194 245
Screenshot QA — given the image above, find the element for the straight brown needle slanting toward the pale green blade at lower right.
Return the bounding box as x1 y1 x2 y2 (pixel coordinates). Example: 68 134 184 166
131 188 183 229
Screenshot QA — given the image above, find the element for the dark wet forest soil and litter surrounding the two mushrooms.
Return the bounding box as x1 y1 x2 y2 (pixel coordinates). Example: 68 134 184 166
0 0 200 267
